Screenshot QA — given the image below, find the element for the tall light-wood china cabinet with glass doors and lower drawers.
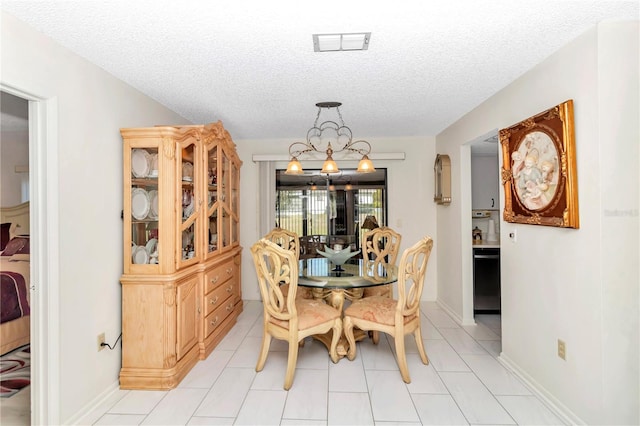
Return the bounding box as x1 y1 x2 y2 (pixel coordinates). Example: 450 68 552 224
120 121 242 389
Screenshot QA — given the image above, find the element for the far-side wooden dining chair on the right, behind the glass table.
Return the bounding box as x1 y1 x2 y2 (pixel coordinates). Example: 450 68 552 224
362 226 402 297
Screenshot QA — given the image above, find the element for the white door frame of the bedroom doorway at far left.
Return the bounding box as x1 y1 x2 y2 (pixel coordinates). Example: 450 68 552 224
0 82 61 424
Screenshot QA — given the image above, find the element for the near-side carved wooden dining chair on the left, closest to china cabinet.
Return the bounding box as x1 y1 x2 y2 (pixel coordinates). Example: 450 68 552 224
251 238 342 390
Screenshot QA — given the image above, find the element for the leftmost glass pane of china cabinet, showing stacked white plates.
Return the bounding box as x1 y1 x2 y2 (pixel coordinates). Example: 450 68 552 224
125 146 160 272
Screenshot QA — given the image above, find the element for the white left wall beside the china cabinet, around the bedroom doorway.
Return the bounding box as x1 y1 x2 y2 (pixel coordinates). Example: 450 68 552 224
0 12 188 424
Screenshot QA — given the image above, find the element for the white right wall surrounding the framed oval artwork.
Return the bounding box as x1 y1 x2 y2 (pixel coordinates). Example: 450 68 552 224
436 22 640 424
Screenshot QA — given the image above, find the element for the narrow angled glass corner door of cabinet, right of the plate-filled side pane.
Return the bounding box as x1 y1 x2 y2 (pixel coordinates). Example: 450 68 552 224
176 138 202 268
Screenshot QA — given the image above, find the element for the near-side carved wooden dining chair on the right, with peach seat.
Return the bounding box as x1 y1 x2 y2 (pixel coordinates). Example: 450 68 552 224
343 237 433 383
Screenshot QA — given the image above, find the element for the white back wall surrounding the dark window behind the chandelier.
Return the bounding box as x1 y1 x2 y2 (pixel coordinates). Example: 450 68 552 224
238 136 439 300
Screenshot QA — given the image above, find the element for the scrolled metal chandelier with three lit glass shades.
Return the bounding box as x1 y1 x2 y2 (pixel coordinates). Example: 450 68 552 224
285 102 376 175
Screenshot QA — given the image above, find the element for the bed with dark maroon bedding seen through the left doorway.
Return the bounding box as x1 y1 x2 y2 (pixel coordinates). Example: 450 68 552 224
0 202 31 354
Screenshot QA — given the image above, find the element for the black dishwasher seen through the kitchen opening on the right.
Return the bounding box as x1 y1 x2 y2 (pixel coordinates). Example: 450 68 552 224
473 248 500 314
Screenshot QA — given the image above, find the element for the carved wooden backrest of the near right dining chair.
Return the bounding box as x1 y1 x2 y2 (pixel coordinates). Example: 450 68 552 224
396 237 433 320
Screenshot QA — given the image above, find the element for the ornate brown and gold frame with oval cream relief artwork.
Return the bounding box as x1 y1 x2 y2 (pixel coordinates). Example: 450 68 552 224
499 100 580 229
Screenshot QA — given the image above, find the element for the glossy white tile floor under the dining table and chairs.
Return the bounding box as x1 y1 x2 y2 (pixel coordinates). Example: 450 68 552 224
3 301 564 426
